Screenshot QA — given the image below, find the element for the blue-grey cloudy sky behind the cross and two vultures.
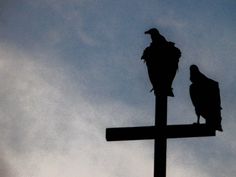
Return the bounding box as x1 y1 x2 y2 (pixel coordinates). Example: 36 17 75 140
0 0 236 177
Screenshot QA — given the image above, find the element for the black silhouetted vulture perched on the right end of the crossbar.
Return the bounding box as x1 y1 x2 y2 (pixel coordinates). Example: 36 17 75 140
190 65 223 131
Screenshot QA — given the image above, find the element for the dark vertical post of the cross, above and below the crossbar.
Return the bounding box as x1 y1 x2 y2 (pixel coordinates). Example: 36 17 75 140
154 95 167 177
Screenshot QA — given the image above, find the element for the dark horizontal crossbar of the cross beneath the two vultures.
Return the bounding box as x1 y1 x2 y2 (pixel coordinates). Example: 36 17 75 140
106 124 216 141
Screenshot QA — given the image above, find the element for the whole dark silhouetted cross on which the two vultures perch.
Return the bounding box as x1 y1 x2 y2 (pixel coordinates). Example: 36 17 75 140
106 95 215 177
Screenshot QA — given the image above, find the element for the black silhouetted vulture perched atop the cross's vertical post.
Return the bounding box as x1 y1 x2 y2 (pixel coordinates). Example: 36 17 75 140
141 28 181 96
